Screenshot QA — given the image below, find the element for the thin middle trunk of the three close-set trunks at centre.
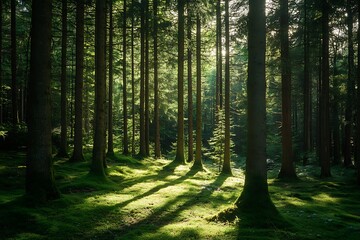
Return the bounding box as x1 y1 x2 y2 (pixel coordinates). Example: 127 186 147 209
187 4 193 162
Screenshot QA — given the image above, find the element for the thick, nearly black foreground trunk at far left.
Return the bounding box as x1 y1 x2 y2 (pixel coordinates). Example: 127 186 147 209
26 0 60 202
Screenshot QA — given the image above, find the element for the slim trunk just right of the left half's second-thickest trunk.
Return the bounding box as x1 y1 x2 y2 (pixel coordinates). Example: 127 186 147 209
106 0 114 157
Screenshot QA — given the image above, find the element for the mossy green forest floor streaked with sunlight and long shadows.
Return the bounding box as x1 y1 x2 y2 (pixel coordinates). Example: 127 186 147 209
0 152 360 240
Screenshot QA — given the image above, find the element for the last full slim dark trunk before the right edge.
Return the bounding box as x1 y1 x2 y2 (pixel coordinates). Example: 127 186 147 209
344 0 355 167
